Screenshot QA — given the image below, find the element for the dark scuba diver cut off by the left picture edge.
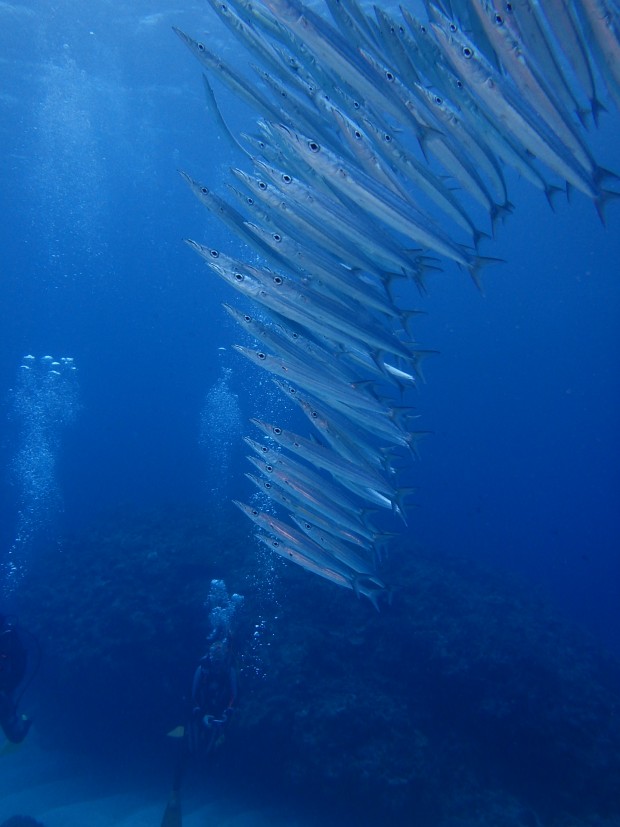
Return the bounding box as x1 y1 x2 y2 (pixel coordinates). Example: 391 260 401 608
0 615 32 744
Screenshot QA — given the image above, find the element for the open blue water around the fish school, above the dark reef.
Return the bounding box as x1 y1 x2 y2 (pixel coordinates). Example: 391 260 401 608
0 0 620 820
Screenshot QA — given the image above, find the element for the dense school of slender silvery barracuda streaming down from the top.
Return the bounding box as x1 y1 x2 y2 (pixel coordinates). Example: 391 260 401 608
175 0 620 607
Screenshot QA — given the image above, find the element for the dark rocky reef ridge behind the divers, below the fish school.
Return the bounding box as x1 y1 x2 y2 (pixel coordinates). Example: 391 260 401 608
14 509 620 827
